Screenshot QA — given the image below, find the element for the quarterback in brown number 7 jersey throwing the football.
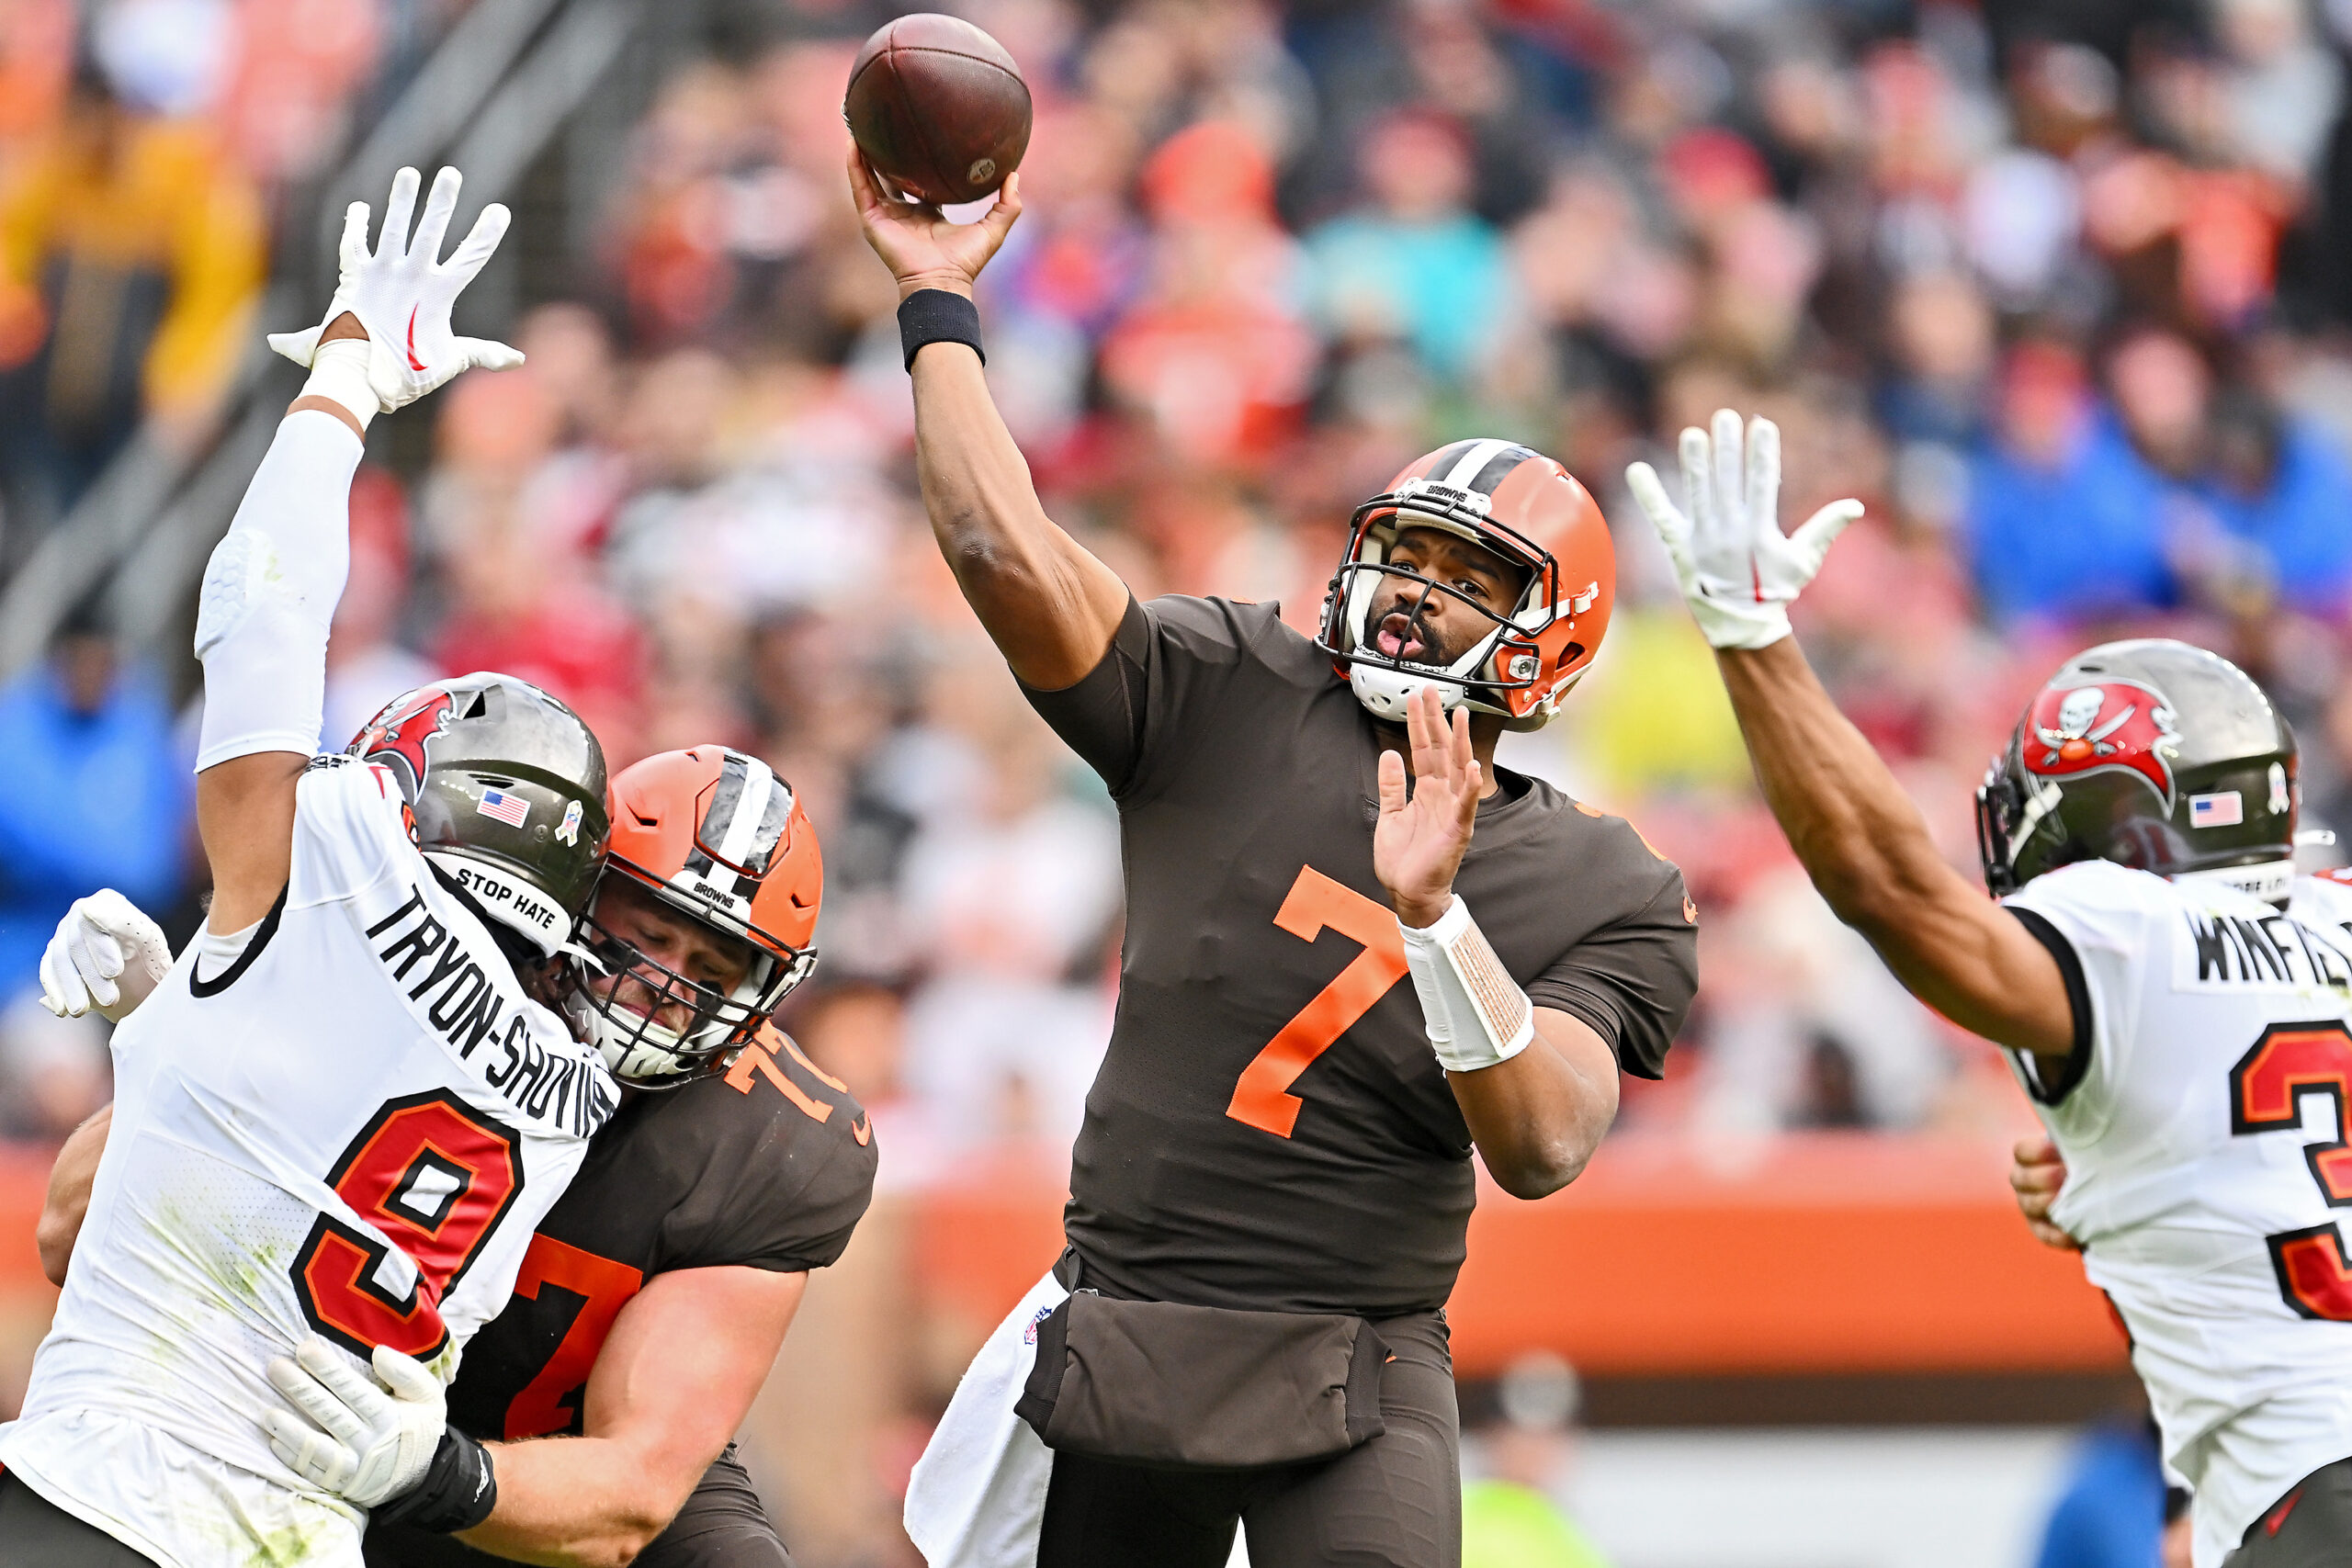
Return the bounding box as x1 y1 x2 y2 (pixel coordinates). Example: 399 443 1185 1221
849 151 1696 1568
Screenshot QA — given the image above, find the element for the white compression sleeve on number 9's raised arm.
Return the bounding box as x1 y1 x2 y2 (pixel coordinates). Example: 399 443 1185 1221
195 409 362 773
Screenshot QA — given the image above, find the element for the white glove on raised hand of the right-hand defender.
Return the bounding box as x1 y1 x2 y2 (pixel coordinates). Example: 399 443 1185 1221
1625 409 1863 649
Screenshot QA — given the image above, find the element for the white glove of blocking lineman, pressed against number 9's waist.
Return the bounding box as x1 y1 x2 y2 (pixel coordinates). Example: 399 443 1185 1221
261 1336 449 1509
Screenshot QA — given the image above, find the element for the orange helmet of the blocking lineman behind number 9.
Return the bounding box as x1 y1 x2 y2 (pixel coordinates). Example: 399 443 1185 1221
581 745 826 1089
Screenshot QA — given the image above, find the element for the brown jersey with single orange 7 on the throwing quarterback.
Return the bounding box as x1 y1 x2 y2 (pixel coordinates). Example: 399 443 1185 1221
1028 597 1698 1319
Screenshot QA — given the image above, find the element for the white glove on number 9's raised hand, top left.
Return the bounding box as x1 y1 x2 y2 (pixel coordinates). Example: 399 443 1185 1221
270 169 522 423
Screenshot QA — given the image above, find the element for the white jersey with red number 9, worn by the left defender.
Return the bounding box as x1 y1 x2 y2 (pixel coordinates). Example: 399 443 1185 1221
0 757 618 1568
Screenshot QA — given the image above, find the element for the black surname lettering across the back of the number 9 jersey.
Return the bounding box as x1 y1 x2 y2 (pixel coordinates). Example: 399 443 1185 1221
367 884 618 1138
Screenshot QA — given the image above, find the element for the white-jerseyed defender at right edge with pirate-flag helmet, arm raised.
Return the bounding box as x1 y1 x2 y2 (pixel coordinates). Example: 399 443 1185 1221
1625 412 2352 1568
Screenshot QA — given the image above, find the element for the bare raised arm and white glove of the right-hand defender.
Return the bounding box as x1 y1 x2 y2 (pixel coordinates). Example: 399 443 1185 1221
1625 409 2075 1067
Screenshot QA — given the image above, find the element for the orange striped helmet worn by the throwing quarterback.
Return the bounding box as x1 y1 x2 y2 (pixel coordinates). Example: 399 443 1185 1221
1315 440 1616 728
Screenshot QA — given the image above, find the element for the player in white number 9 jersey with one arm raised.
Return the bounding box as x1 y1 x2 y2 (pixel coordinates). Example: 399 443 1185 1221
0 169 618 1568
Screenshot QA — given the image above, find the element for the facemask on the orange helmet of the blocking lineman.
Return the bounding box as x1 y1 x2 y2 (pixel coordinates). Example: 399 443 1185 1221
576 865 816 1089
